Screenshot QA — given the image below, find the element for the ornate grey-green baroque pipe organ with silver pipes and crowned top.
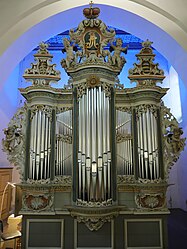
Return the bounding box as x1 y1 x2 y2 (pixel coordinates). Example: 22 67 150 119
3 4 185 249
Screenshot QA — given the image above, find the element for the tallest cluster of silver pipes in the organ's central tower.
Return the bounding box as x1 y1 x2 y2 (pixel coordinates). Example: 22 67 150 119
78 86 111 201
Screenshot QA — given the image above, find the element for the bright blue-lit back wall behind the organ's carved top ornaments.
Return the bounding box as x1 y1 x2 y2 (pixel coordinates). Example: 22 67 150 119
18 29 182 122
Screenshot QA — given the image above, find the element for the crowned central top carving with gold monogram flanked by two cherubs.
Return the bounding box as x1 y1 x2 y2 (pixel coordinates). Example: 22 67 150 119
61 6 127 72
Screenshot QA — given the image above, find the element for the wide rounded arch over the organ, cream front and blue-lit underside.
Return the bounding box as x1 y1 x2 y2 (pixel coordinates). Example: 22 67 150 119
0 3 187 89
